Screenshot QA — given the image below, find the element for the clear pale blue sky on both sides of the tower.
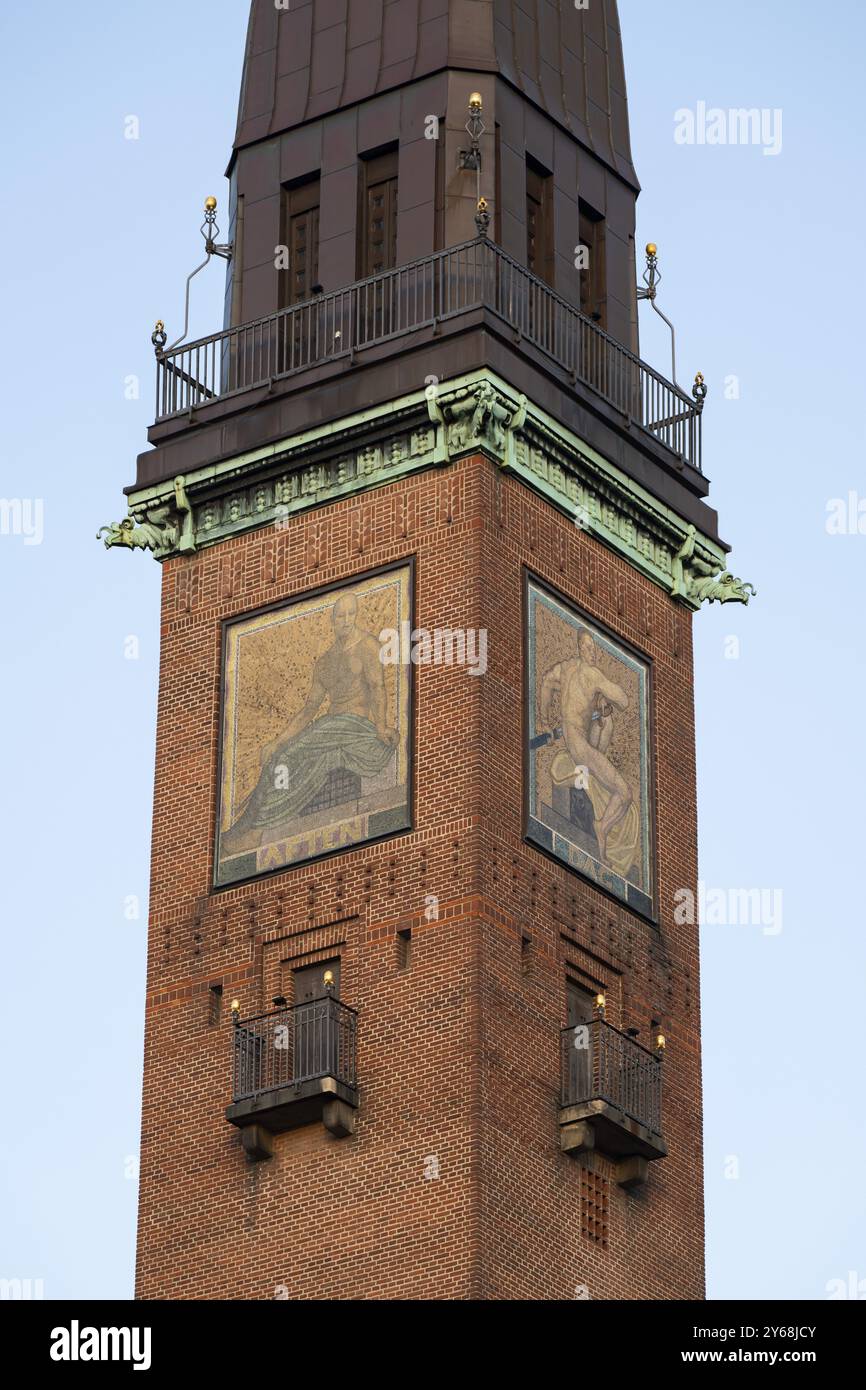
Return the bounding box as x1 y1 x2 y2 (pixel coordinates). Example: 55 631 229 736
0 0 866 1300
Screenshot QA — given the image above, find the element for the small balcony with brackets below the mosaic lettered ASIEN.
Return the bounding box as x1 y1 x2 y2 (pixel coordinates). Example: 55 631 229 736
225 995 359 1159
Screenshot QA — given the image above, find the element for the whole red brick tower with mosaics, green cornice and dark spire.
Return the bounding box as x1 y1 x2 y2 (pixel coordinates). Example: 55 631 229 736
104 0 749 1300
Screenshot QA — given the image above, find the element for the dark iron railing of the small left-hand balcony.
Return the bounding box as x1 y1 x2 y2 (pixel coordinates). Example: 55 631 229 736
232 995 357 1101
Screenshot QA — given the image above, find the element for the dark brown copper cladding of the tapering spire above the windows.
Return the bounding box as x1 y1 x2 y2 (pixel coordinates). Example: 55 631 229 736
235 0 639 189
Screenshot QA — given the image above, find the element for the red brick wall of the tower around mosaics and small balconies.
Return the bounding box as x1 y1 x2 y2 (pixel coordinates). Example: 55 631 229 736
138 456 703 1300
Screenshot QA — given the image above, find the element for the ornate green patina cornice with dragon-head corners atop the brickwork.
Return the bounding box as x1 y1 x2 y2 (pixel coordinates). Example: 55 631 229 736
100 370 755 609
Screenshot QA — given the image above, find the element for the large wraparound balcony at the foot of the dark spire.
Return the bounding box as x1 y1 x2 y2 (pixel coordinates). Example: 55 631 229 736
150 236 705 475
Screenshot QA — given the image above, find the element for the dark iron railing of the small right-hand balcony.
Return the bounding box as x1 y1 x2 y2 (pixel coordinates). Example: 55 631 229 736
562 1019 662 1134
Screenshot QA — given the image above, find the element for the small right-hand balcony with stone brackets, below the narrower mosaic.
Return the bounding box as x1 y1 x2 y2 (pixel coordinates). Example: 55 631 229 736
559 1017 667 1187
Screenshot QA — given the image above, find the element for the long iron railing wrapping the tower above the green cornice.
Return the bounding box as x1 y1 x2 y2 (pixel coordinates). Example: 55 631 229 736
156 238 703 468
